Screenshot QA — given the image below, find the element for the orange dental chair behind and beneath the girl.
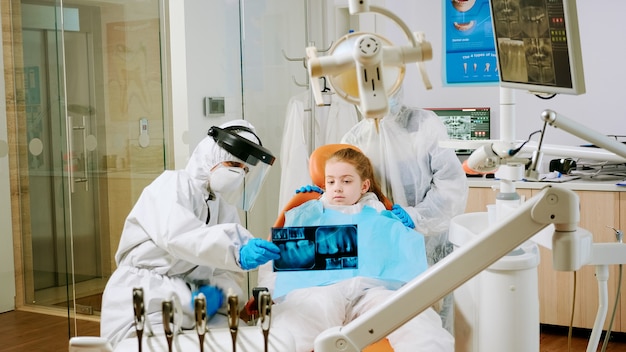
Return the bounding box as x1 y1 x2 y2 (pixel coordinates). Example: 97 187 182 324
274 144 393 352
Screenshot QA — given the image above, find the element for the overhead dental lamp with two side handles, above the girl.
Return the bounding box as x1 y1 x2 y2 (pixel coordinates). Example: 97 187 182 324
306 0 432 118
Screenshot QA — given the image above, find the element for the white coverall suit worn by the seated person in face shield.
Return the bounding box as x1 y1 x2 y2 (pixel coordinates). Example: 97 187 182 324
101 129 253 346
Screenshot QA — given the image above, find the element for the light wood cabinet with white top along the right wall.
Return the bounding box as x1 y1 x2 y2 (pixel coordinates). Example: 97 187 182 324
466 179 626 332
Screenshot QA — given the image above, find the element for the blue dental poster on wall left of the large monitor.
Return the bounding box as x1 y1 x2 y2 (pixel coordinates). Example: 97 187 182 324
443 0 499 85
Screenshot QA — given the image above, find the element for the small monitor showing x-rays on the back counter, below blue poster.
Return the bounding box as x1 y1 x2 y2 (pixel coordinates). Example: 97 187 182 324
426 107 491 155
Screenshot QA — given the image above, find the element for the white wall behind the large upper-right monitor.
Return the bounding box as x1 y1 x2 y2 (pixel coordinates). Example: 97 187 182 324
386 0 626 151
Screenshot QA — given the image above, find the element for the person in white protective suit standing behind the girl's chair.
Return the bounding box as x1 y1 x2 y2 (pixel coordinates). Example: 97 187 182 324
341 89 468 332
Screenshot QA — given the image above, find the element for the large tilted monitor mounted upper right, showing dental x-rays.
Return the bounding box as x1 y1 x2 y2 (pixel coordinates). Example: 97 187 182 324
490 0 585 95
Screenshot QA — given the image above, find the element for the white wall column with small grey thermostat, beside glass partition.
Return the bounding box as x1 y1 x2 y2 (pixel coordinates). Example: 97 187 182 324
170 0 242 169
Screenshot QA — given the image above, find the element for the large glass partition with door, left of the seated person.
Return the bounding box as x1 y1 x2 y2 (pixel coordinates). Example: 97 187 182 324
3 0 169 332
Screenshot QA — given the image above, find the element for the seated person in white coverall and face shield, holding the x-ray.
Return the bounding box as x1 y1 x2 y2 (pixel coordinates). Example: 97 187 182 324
100 120 279 346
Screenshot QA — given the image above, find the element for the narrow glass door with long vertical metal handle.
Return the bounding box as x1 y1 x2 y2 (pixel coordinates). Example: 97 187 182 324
22 4 102 305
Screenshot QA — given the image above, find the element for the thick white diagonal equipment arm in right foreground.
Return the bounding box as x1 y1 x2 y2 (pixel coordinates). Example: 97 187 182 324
315 186 591 352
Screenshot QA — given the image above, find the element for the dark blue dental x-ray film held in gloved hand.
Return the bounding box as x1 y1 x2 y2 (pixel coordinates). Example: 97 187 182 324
272 225 359 271
